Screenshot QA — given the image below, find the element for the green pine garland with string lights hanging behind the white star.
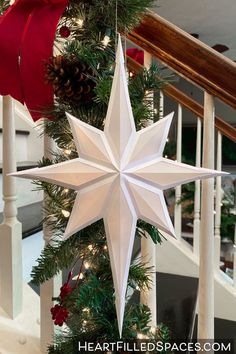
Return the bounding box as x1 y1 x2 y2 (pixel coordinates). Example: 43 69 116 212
2 0 173 354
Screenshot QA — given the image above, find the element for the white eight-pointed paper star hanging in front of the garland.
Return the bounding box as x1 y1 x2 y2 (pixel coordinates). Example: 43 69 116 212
12 36 227 335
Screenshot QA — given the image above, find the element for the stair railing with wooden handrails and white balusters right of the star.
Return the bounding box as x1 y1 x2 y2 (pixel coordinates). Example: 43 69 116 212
127 12 236 338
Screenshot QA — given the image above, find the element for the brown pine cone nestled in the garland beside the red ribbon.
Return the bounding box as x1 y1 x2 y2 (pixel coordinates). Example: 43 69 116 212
45 55 95 104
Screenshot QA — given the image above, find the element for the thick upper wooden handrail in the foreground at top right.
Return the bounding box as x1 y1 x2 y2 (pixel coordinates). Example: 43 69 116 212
127 12 236 109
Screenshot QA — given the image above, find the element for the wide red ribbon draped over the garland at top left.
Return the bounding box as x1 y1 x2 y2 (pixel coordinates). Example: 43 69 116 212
0 0 68 121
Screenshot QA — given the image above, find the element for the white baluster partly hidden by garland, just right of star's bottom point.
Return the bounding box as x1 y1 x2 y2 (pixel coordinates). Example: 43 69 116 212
140 52 157 327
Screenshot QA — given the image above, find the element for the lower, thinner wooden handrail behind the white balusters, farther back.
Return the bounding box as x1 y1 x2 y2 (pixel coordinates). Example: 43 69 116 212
127 57 236 143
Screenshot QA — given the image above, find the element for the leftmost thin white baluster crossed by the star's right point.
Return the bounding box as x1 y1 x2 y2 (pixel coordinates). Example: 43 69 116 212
175 104 183 239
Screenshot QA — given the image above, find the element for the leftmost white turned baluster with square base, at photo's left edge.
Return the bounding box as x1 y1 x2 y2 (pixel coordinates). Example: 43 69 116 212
0 96 23 318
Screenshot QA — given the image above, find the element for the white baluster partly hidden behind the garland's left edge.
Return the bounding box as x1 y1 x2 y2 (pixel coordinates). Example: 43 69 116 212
40 127 61 354
